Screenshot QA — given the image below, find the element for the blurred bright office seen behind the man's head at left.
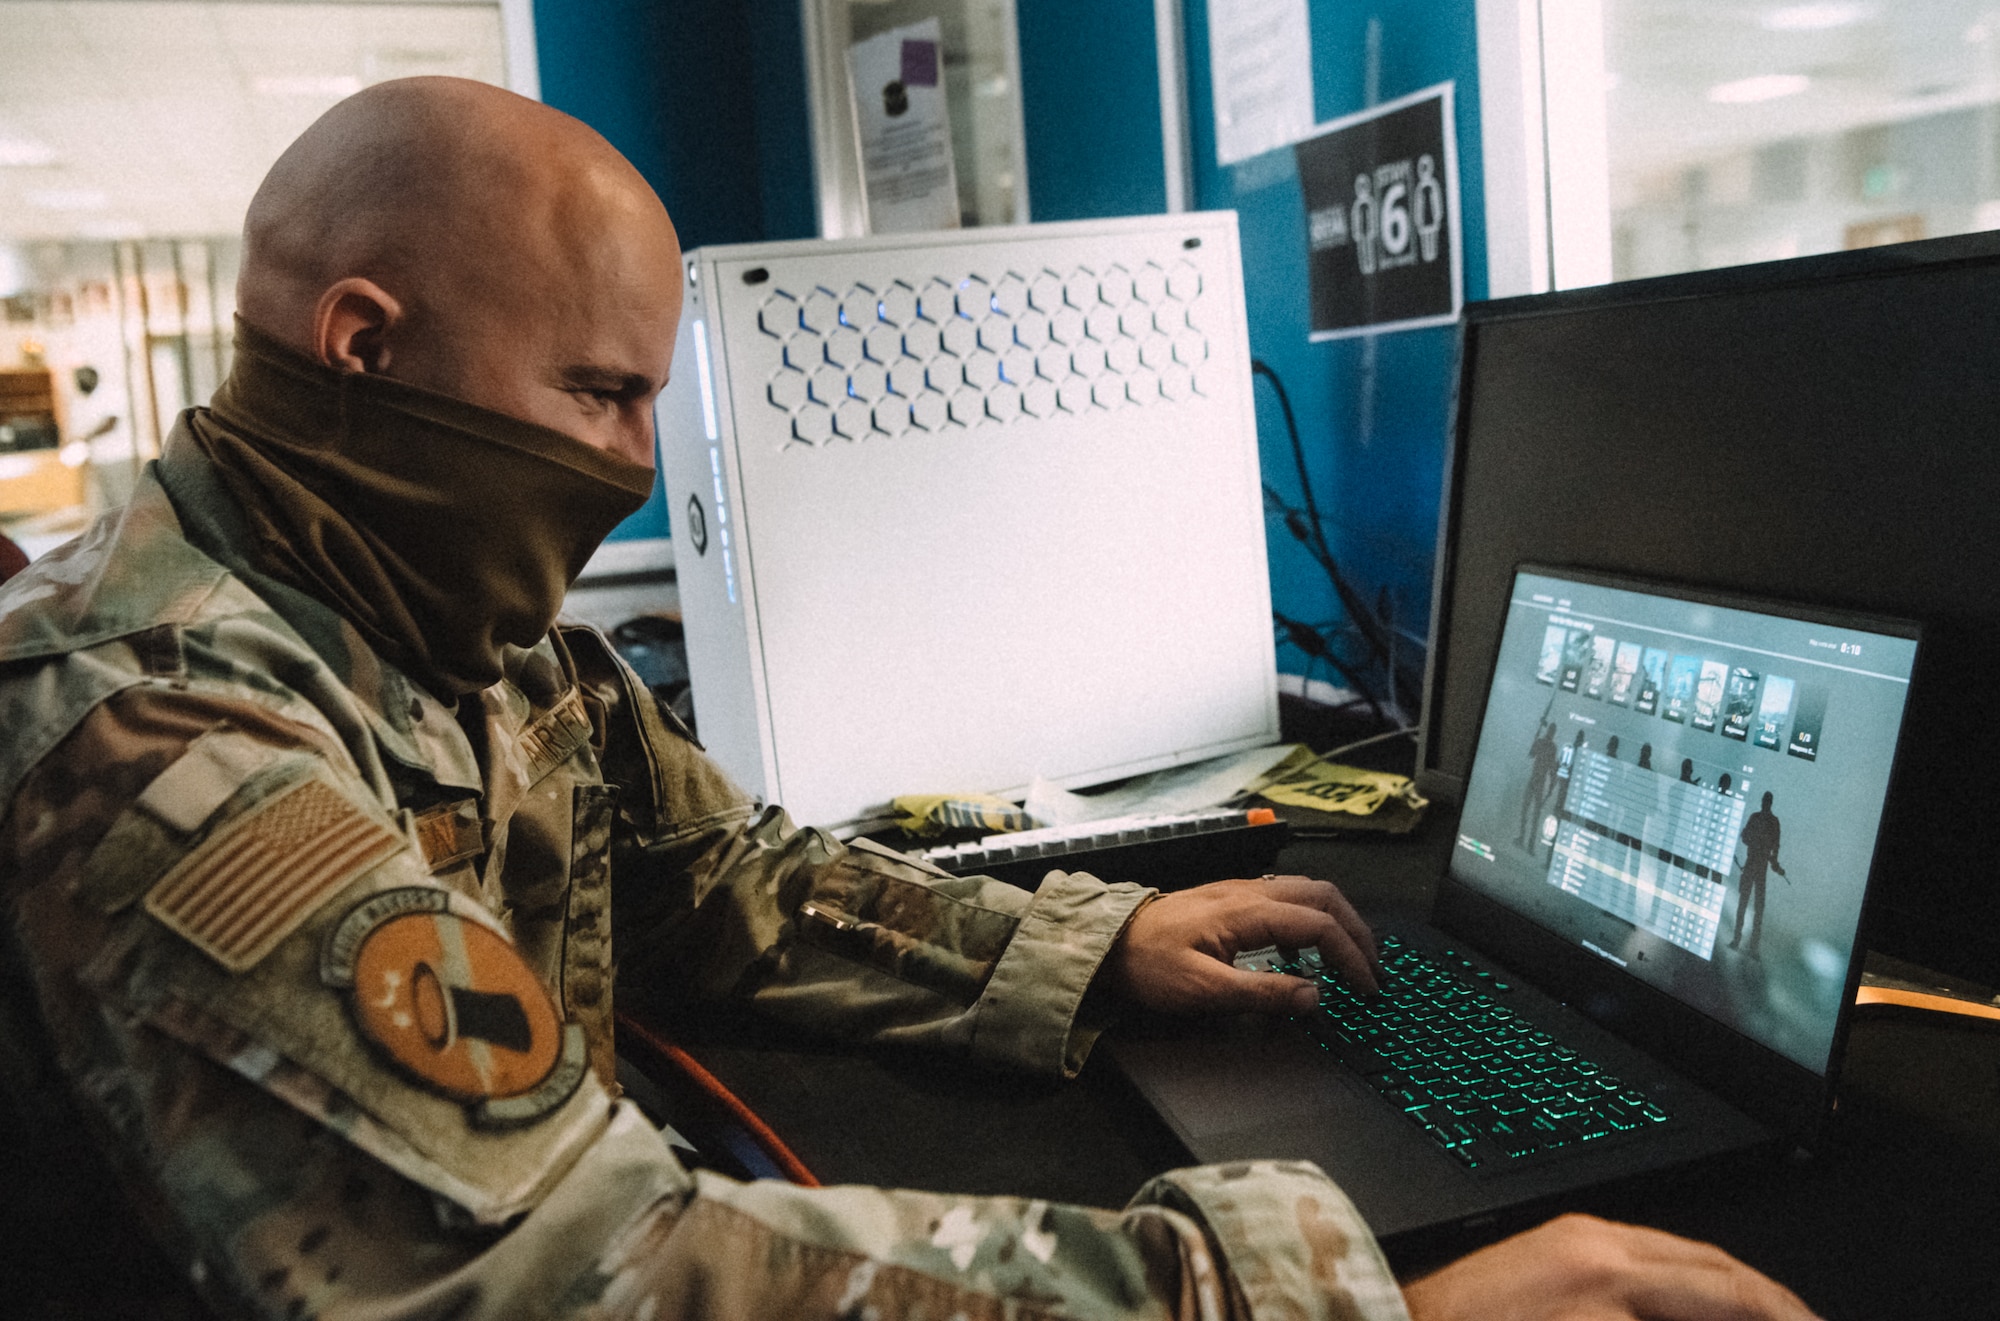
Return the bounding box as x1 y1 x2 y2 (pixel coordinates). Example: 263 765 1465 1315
0 0 506 552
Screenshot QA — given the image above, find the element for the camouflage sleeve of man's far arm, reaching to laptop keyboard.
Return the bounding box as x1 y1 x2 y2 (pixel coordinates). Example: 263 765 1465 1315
566 630 1152 1075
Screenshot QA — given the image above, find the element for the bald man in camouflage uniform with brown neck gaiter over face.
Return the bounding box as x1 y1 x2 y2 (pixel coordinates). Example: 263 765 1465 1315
0 78 1806 1319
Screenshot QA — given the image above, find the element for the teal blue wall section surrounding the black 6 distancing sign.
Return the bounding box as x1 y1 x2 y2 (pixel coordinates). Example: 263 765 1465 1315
1186 0 1486 715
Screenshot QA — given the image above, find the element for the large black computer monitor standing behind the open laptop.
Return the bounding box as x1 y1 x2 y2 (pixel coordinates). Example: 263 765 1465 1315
1420 234 2000 983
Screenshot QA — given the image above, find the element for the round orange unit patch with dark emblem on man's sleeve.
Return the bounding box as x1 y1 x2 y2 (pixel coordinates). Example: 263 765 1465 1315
328 891 574 1109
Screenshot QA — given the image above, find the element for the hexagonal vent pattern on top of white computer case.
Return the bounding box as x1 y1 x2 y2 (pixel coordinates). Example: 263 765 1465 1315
758 260 1208 444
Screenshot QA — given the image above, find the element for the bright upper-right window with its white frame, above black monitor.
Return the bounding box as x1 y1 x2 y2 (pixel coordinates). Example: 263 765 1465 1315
1480 0 2000 294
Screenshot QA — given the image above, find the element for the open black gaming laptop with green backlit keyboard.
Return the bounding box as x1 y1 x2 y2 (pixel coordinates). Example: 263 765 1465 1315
1108 566 1918 1237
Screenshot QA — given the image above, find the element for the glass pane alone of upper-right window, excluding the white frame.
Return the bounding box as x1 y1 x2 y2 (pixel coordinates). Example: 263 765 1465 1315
1604 0 2000 280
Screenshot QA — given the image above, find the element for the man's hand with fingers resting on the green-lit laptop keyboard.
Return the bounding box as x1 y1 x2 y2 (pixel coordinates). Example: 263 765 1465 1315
1104 877 1376 1013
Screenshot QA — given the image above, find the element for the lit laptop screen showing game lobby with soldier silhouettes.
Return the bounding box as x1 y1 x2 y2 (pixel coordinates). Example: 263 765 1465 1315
1452 568 1916 1075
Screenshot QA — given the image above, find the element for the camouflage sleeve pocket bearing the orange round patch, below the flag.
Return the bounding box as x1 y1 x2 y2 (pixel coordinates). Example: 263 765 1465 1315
82 868 612 1225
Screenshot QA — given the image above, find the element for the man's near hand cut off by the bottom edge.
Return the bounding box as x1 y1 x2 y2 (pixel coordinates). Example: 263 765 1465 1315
1402 1215 1812 1321
